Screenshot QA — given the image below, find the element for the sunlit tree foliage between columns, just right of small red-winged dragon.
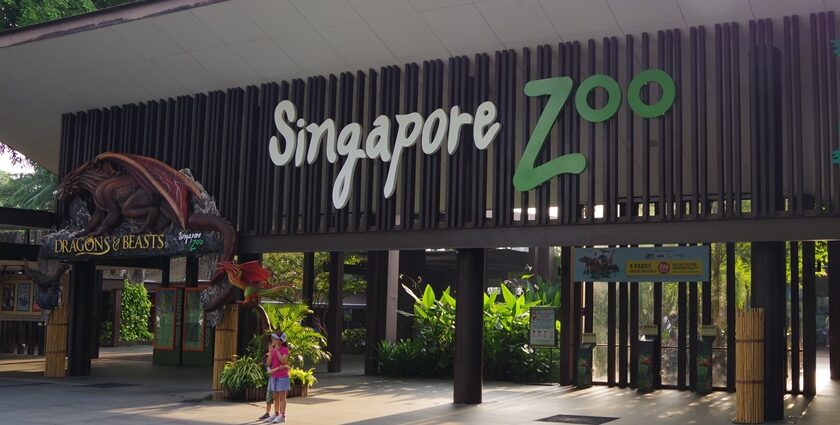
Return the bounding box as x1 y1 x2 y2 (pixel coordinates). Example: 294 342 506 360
263 252 367 304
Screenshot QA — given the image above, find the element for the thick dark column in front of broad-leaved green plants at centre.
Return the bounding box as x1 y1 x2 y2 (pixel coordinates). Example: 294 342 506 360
453 248 485 404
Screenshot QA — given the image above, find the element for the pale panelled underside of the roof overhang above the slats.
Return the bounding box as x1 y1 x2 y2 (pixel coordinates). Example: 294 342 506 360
0 0 840 171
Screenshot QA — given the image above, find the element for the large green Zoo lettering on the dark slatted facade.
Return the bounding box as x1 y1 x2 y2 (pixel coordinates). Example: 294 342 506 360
513 69 677 192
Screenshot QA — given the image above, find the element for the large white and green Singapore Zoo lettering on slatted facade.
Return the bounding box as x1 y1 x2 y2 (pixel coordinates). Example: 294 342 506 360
268 69 676 209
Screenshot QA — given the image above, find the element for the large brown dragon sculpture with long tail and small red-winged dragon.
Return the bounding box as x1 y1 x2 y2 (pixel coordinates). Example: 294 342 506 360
39 152 273 312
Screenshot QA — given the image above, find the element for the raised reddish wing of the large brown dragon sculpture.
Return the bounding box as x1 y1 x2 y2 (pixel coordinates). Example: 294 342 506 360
96 152 201 229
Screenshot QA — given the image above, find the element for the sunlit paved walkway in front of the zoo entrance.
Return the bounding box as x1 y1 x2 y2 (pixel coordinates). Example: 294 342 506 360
0 347 840 425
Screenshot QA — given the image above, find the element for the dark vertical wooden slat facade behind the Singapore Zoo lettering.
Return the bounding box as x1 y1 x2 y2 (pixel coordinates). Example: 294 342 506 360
60 12 840 250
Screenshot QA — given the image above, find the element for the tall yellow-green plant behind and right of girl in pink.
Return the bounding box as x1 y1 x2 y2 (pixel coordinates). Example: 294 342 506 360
262 303 332 368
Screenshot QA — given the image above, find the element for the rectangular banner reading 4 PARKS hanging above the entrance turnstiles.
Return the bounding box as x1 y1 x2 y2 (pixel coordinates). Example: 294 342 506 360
572 246 709 282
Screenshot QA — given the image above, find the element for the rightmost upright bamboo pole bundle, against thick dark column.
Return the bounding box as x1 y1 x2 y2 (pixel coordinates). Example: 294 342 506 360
735 308 764 424
